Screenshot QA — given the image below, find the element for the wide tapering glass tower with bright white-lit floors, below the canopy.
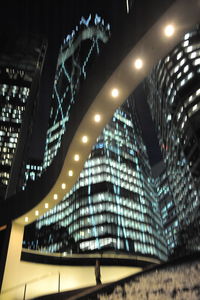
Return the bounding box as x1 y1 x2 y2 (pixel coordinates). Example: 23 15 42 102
26 101 166 260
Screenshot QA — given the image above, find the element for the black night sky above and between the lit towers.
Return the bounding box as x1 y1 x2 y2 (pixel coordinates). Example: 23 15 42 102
0 0 161 165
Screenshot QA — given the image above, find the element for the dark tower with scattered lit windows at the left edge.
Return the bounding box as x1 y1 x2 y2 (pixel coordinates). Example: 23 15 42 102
0 36 47 197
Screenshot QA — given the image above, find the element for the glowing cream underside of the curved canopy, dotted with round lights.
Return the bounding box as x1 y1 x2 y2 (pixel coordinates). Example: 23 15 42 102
1 0 200 224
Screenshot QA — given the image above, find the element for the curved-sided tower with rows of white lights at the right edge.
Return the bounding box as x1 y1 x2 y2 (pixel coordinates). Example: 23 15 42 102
148 25 200 250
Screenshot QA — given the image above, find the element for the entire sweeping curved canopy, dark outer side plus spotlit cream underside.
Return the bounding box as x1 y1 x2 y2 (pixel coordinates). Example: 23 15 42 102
0 0 200 225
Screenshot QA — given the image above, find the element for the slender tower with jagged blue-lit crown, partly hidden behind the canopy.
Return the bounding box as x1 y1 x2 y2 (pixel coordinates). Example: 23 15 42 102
23 14 110 188
